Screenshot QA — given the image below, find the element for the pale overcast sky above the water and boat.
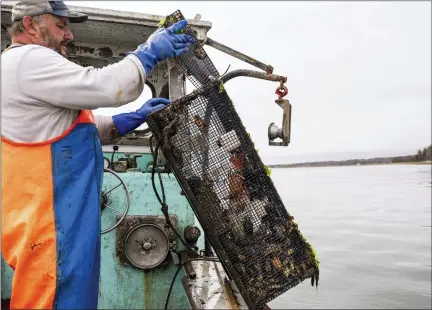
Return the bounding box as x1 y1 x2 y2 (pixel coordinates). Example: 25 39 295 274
16 1 431 161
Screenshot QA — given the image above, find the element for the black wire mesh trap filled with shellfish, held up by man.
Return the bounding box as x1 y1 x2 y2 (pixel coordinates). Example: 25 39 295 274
147 11 319 308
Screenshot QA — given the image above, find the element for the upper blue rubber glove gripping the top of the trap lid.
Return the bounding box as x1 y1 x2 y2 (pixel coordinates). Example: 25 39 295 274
126 20 195 75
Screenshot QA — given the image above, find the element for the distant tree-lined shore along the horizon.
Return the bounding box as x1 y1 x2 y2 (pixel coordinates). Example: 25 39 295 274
268 145 432 168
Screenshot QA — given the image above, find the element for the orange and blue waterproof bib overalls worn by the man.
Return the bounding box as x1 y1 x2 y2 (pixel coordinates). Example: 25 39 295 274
1 101 103 309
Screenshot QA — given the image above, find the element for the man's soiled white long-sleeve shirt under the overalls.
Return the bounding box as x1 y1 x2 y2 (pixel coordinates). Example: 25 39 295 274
1 44 146 142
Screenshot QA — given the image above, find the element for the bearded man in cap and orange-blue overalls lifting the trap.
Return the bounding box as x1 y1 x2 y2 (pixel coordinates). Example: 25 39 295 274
1 1 193 309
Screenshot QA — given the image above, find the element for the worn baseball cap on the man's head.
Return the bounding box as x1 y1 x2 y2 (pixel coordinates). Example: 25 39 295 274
12 0 88 23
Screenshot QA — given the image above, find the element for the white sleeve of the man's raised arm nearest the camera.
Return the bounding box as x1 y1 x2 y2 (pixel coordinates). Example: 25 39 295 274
17 45 146 110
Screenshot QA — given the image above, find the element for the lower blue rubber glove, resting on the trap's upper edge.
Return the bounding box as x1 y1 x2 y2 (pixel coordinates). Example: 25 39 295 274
112 98 170 136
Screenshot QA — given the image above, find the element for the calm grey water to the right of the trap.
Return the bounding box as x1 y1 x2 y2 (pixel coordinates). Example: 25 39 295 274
269 165 432 309
